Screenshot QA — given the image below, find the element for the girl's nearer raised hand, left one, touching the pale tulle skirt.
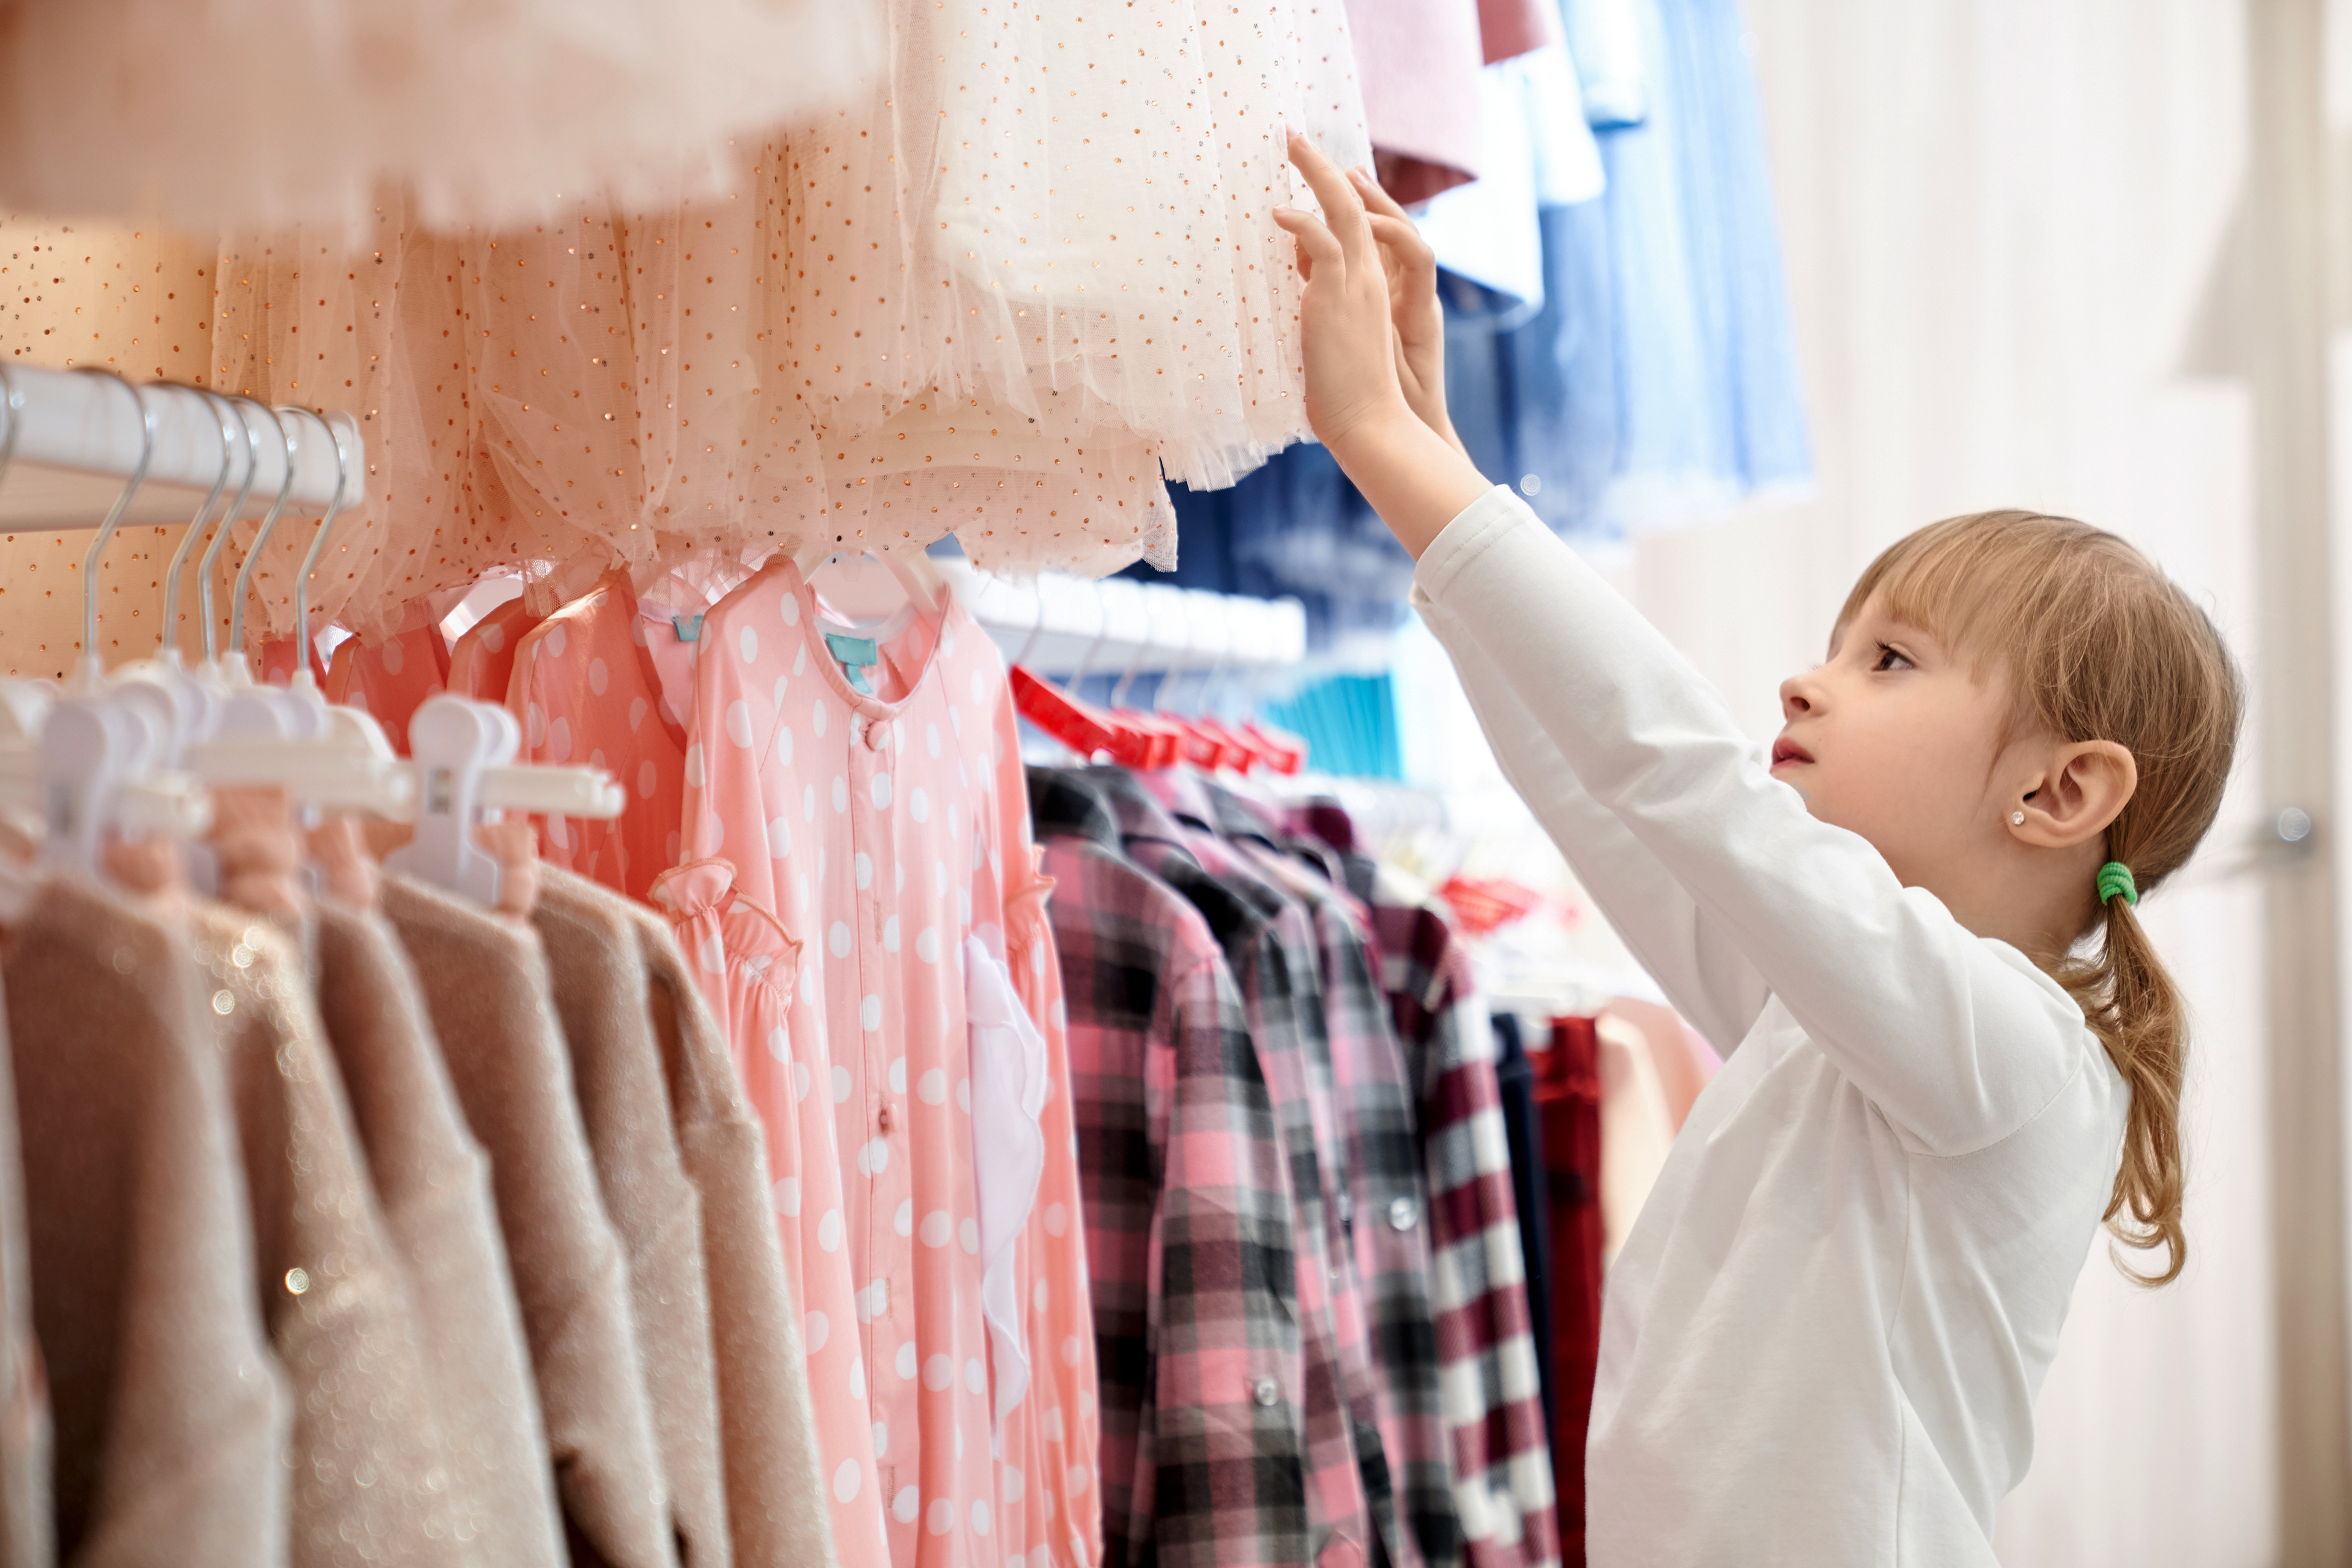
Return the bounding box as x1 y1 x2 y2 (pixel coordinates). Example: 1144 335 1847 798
1275 131 1414 451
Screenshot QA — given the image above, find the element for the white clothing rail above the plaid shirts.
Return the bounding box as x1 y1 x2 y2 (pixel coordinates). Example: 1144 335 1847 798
938 560 1308 675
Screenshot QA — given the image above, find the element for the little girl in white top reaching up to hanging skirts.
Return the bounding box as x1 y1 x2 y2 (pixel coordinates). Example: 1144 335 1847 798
1277 139 2241 1568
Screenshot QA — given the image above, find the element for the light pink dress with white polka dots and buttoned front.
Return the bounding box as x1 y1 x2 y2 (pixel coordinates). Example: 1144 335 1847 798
684 573 1100 1568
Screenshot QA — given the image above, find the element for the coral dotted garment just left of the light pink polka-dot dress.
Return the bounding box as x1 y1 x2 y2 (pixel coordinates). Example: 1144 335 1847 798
506 571 687 898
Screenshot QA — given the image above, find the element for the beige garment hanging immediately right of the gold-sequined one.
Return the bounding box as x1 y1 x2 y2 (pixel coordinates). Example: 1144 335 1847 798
313 898 565 1568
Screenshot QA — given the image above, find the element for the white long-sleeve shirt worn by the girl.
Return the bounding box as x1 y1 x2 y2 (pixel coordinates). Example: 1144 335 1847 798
1414 487 2129 1568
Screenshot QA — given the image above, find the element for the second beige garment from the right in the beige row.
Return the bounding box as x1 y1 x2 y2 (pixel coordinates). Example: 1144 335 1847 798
532 865 734 1568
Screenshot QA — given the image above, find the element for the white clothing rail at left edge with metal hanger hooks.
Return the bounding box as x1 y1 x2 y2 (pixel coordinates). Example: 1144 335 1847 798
0 364 367 531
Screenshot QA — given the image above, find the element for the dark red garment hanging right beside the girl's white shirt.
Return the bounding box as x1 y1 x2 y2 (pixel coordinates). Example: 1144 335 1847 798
1536 1018 1604 1568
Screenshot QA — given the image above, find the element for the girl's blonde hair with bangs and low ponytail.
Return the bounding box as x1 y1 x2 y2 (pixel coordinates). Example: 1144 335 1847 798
1837 510 2246 1286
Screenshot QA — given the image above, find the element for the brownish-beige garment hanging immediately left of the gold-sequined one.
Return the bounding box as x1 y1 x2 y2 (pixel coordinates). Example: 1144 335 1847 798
0 877 294 1568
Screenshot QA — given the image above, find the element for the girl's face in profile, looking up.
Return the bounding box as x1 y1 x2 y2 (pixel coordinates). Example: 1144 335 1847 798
1771 599 2018 898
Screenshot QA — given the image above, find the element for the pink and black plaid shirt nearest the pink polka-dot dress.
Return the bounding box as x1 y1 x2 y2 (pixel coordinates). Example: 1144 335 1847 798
1028 769 1310 1568
